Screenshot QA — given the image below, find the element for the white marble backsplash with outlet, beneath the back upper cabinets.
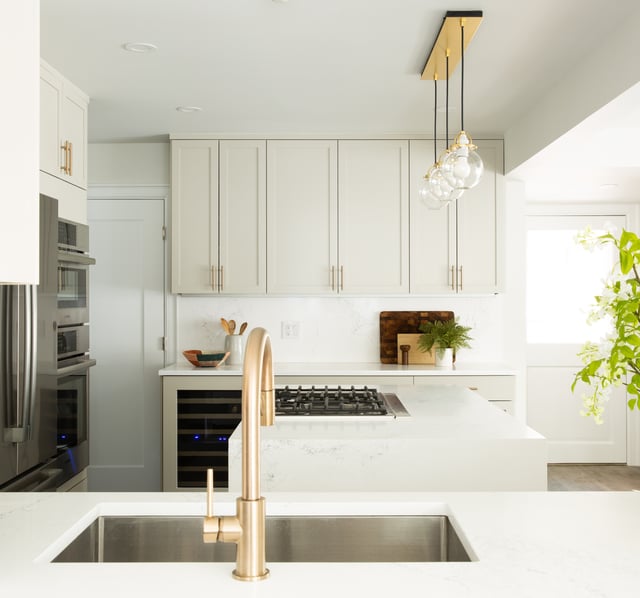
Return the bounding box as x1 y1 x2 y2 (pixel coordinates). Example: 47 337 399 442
175 295 506 362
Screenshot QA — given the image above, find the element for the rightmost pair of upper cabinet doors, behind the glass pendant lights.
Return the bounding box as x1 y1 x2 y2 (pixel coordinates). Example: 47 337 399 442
410 140 503 294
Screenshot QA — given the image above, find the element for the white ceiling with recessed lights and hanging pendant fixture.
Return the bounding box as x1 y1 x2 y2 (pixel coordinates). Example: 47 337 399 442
41 0 639 203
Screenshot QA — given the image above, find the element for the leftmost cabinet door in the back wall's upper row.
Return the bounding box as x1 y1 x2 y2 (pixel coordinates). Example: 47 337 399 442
171 140 218 293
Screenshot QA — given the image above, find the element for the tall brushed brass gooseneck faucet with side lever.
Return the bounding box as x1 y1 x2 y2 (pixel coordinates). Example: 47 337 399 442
203 328 275 581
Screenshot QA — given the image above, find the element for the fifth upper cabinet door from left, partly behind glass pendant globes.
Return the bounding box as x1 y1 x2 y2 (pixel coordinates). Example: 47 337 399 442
409 140 456 294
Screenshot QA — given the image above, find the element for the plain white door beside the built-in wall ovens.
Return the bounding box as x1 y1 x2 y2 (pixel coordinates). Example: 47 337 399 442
89 199 165 491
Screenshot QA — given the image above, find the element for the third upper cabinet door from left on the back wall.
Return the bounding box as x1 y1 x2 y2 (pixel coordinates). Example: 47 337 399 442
267 140 338 295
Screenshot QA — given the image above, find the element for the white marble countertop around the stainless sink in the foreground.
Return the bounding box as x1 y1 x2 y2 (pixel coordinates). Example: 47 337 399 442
0 492 640 598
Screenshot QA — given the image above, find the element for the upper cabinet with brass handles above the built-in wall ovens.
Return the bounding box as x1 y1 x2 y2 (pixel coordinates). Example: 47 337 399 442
40 61 89 222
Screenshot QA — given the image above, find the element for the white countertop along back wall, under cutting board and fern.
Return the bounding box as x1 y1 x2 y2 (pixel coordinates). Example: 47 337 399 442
159 358 516 376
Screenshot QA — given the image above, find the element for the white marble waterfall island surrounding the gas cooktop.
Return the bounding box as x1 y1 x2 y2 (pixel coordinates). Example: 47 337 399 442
229 385 547 492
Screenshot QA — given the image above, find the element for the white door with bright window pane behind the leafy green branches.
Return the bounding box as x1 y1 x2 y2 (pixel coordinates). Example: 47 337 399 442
527 215 627 463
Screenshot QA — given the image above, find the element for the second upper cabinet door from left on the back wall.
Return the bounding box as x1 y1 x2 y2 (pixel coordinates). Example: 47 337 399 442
218 140 267 294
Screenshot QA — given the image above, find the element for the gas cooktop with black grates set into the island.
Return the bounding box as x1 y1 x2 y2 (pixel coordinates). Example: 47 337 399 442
275 386 408 416
